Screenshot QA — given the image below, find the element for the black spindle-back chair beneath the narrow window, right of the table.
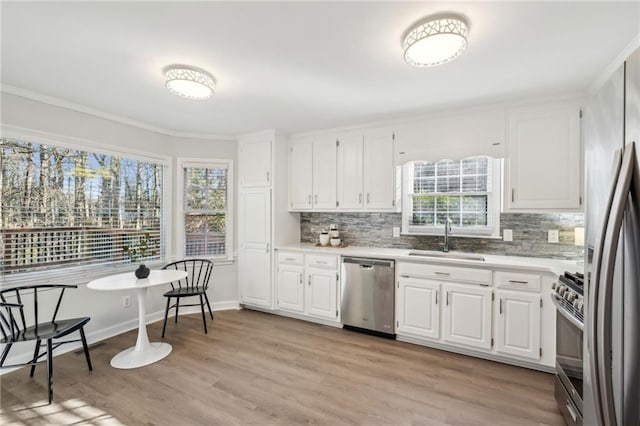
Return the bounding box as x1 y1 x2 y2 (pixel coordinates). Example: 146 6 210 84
162 259 213 337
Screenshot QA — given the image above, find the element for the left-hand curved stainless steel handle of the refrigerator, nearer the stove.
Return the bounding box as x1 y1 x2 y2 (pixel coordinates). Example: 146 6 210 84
587 150 622 425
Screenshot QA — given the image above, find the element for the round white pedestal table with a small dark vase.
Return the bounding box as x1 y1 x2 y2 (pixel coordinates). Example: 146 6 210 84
87 270 187 369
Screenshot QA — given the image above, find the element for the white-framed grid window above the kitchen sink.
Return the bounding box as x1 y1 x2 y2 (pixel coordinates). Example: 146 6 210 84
403 157 500 235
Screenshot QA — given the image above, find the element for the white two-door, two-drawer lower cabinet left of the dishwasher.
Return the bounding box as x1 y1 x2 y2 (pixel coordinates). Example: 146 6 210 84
276 250 340 322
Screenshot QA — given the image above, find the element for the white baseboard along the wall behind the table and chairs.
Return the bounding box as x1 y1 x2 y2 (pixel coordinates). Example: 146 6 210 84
0 300 240 375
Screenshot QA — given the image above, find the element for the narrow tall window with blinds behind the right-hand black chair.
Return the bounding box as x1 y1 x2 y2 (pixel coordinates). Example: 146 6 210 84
178 159 233 258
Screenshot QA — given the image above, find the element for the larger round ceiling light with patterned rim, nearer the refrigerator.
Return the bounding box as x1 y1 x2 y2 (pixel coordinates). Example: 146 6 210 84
403 15 469 67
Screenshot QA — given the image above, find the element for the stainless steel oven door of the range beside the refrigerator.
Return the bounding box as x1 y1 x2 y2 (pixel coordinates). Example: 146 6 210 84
556 298 583 415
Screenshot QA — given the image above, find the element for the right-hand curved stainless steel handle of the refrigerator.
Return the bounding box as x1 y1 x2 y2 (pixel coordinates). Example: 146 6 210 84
597 144 636 425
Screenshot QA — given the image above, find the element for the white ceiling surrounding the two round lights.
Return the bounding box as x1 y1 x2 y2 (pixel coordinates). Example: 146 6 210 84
1 1 640 135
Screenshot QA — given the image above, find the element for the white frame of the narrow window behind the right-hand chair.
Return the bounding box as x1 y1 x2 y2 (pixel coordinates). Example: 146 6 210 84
175 157 234 261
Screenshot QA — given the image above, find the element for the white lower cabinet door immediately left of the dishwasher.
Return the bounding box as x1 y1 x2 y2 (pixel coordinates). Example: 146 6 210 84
306 268 338 320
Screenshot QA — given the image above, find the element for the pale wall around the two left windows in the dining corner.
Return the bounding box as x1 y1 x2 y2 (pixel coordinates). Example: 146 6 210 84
0 93 238 364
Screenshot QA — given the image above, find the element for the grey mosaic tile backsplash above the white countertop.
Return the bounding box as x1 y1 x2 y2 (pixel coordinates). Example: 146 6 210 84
300 213 584 260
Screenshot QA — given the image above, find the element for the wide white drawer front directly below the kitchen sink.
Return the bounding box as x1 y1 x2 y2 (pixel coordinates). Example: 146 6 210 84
398 262 491 286
